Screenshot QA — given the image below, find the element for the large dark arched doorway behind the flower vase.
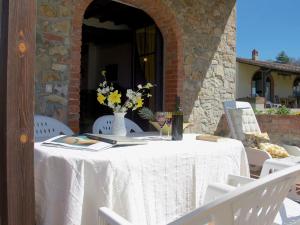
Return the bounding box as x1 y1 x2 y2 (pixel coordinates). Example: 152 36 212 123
80 0 164 132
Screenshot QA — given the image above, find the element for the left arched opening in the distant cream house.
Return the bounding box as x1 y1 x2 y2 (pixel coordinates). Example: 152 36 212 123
251 71 274 101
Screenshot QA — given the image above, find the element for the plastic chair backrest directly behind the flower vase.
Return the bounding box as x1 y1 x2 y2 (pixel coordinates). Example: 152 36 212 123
93 115 143 134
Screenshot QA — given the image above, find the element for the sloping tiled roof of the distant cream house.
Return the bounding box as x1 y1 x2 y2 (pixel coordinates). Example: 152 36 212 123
236 58 300 74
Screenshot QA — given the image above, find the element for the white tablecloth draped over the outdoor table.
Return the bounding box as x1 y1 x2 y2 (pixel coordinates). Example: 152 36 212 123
35 135 249 225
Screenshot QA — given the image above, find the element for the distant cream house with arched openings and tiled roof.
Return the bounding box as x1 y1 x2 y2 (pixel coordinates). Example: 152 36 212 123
236 50 300 108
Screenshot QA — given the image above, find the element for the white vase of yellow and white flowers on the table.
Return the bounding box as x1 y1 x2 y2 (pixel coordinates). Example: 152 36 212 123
97 70 153 136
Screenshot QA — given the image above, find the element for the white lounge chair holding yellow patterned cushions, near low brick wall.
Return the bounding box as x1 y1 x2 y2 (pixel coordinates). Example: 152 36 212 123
223 100 300 169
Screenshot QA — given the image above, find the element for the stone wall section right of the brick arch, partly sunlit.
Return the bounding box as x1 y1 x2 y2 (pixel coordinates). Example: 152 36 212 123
172 0 236 133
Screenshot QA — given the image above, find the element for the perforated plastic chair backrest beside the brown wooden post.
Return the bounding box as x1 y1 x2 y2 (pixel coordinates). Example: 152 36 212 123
34 115 73 141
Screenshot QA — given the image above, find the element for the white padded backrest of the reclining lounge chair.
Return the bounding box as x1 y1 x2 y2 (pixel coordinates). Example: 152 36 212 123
223 100 261 140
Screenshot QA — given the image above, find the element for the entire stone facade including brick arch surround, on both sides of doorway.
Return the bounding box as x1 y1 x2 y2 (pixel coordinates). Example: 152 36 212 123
35 0 236 133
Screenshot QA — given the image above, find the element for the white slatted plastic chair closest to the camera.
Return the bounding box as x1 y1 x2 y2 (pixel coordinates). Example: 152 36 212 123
99 166 300 225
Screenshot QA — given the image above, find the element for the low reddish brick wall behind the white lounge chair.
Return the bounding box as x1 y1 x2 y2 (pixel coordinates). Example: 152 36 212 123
215 115 300 147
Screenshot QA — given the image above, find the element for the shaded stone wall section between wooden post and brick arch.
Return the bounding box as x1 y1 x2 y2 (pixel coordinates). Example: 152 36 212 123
35 0 74 122
